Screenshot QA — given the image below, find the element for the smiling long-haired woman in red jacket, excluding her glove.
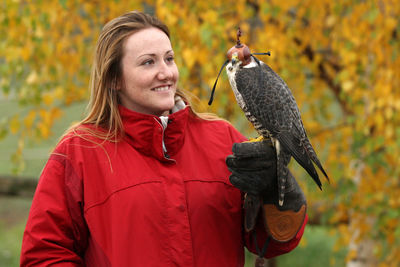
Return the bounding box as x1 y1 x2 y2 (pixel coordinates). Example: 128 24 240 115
21 12 305 266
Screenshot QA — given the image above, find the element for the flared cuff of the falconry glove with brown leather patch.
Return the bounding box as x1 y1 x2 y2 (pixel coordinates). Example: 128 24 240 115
262 172 307 242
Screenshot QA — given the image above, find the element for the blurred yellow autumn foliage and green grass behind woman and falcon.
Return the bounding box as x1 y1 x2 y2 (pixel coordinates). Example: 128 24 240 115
0 0 400 267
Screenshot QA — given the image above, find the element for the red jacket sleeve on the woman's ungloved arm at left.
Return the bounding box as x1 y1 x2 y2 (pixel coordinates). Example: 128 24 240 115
20 154 88 266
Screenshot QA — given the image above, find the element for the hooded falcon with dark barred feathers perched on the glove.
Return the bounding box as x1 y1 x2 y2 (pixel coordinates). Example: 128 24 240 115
209 28 329 206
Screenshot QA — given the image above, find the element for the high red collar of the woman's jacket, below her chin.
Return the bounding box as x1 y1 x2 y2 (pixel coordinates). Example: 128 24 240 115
118 105 189 162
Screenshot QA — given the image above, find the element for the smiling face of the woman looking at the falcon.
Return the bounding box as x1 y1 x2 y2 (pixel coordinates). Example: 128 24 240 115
117 28 179 116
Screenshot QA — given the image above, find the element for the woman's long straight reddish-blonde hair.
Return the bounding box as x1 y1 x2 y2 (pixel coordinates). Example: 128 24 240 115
64 11 219 141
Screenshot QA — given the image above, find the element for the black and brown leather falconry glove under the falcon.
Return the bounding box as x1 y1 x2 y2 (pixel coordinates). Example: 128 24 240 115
226 139 307 242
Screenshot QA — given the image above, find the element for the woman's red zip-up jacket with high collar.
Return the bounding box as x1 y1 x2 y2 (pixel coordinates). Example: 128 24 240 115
21 107 304 267
